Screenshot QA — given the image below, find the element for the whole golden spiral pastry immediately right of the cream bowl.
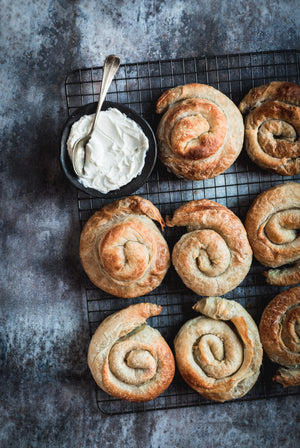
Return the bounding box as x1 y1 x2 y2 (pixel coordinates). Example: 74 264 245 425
156 84 244 180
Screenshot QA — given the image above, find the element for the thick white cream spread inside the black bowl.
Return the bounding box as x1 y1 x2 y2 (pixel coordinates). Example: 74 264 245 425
67 108 149 193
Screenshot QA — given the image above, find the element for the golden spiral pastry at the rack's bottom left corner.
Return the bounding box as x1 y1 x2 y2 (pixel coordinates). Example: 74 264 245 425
88 303 175 402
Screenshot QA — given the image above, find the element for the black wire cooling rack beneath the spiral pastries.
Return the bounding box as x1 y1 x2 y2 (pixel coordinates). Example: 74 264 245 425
65 50 300 414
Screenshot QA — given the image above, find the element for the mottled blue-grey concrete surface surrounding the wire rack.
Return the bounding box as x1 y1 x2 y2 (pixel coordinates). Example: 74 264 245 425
0 0 300 448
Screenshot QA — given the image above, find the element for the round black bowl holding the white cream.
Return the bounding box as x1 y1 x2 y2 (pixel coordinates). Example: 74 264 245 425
60 101 157 199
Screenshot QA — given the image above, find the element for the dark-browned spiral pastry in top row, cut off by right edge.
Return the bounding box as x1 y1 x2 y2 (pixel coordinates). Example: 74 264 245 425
239 81 300 176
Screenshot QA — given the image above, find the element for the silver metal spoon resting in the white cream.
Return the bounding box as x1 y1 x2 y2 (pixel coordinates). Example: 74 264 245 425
72 55 120 177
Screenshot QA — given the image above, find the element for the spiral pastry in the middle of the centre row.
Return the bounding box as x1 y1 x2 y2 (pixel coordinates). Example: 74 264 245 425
166 199 252 296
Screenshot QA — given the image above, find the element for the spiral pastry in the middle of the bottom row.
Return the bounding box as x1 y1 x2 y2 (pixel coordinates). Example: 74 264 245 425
174 297 263 402
